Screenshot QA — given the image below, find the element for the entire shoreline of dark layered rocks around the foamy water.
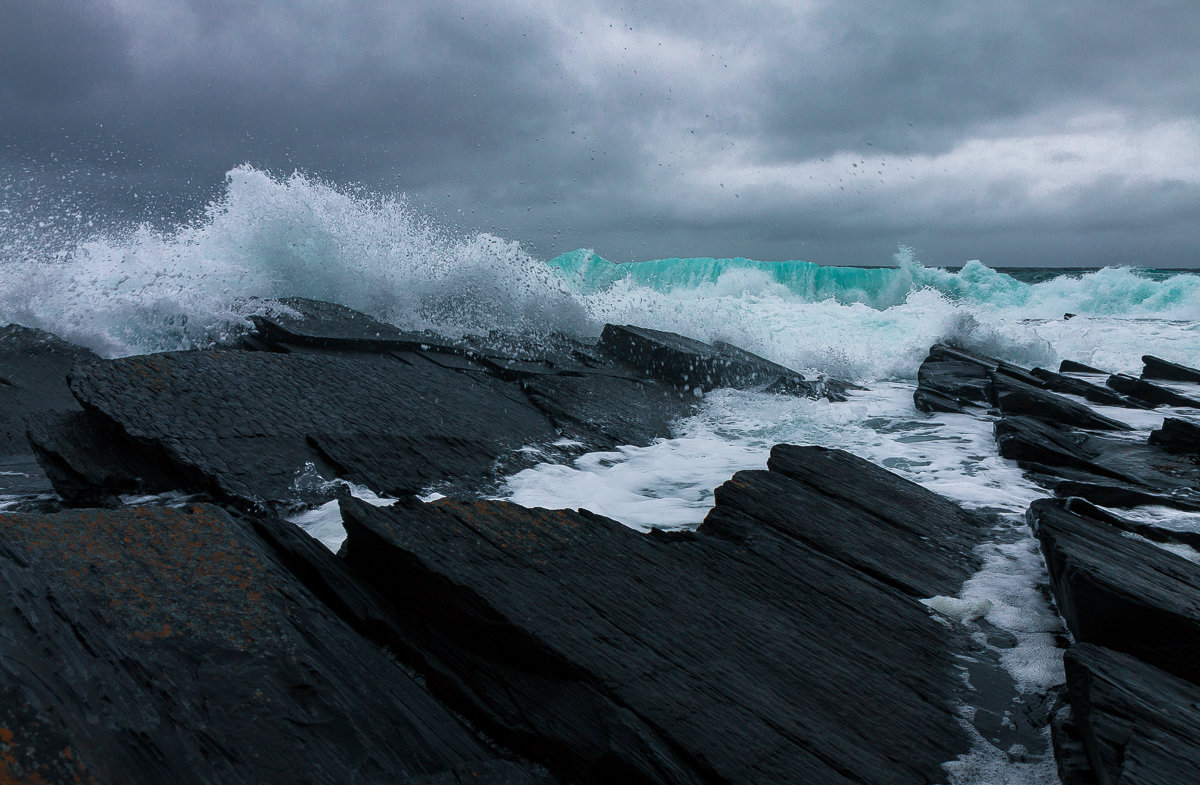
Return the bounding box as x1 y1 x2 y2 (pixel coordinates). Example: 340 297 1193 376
0 299 1200 785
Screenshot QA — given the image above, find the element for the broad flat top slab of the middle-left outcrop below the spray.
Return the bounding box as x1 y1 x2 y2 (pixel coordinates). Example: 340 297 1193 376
62 352 557 511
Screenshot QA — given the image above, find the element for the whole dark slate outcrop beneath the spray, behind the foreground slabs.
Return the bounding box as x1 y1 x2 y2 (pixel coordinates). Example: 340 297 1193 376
30 298 864 509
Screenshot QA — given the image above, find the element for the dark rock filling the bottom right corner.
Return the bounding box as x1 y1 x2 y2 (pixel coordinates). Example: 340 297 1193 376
1064 643 1200 785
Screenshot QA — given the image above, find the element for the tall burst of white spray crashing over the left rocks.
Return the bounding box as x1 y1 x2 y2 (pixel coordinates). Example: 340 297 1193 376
0 166 587 356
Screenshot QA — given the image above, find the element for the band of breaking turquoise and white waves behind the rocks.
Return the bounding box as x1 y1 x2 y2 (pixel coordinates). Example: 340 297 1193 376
0 166 1200 382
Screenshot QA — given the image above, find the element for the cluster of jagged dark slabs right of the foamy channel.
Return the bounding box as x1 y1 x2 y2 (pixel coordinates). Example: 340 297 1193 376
914 346 1200 785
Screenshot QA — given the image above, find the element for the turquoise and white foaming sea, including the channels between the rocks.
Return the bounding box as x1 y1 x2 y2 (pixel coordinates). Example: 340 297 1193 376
0 166 1200 785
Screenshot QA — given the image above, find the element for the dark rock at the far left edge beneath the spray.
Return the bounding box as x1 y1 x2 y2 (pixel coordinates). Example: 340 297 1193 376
0 324 97 456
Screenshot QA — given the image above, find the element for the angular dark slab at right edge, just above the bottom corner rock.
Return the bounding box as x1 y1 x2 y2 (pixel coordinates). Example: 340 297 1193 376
1028 499 1200 682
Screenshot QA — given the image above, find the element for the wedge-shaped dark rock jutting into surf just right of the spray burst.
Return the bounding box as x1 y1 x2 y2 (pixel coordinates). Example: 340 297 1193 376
600 324 844 396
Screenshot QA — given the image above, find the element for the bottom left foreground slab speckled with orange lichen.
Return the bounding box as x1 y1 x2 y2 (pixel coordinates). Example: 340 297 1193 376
0 507 544 785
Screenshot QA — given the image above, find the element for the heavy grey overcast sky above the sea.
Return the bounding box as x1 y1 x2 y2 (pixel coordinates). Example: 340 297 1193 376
0 0 1200 266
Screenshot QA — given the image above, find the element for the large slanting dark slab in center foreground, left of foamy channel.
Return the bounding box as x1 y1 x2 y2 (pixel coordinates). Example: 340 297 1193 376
342 451 970 785
